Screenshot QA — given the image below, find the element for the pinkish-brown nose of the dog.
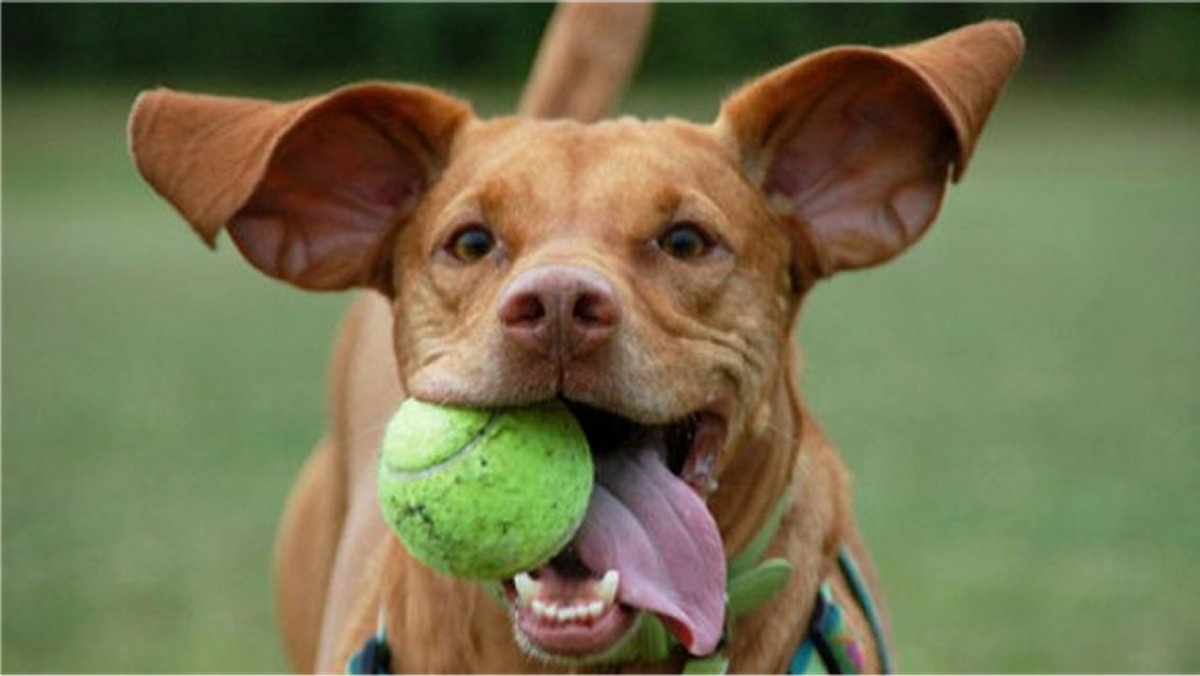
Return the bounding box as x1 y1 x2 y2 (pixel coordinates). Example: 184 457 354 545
497 265 620 361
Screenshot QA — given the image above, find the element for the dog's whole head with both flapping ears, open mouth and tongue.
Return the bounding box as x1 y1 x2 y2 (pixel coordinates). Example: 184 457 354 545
131 23 1021 657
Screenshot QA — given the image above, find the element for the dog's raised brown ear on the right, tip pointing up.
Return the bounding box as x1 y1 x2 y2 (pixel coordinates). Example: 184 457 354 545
716 22 1024 276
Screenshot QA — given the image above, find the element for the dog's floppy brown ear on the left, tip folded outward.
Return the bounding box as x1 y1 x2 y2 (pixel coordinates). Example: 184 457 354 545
130 84 472 293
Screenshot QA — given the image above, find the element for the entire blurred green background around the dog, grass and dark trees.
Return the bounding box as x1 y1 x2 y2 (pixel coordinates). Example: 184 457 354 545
0 4 1200 672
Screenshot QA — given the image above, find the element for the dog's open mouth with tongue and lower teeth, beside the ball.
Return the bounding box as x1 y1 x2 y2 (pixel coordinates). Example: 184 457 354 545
504 402 727 659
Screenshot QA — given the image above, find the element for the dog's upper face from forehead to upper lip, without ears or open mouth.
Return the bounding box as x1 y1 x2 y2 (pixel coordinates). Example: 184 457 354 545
394 119 808 451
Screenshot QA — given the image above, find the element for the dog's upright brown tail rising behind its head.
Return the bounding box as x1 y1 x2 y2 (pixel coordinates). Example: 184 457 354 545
517 2 652 122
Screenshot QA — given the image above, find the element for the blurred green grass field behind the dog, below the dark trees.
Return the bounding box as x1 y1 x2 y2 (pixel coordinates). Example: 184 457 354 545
2 83 1200 671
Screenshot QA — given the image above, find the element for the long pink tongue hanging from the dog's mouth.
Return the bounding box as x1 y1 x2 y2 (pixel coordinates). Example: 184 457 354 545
575 443 725 654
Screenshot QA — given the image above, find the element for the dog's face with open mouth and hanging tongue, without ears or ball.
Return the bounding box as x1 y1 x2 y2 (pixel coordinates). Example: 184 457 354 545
392 120 796 657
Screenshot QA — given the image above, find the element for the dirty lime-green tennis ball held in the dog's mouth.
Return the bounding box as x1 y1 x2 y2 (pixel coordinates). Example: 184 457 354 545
379 399 593 580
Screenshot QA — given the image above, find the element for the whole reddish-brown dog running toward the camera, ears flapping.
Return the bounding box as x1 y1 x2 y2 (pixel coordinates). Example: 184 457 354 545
131 7 1022 672
